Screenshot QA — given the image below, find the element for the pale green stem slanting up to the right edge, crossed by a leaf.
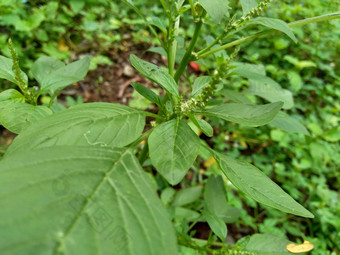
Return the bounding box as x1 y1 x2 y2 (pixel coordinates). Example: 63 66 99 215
197 12 340 59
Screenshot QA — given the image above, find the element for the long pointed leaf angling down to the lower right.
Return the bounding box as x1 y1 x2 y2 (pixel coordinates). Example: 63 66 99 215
210 149 314 218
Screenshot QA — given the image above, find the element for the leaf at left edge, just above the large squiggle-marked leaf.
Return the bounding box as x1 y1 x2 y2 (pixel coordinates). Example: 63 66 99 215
0 100 53 134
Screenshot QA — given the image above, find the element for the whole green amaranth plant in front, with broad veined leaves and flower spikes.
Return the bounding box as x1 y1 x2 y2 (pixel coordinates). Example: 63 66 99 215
0 0 340 254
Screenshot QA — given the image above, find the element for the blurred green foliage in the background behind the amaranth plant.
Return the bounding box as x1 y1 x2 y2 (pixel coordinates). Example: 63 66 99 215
0 0 340 255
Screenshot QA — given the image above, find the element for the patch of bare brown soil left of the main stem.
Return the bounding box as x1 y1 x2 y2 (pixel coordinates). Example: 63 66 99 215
61 44 166 104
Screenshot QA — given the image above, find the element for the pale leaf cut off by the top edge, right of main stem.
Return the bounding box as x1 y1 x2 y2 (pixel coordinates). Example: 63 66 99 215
199 0 230 23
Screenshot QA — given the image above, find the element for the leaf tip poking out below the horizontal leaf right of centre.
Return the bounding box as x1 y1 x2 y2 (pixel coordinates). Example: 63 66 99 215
270 112 310 135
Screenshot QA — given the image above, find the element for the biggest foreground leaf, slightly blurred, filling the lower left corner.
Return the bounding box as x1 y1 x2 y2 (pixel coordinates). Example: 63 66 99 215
0 146 177 255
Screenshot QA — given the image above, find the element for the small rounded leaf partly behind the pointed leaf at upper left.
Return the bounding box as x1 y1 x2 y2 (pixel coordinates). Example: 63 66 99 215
31 56 65 84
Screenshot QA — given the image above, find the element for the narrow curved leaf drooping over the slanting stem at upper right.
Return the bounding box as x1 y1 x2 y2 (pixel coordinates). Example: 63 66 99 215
247 17 297 43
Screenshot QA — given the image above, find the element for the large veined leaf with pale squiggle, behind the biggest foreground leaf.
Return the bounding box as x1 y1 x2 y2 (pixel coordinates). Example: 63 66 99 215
7 103 145 153
